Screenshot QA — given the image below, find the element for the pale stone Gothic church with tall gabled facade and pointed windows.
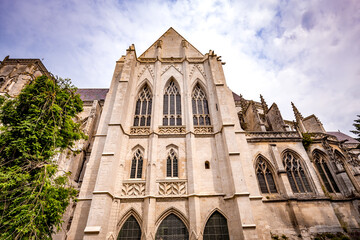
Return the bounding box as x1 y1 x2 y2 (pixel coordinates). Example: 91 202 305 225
0 28 360 240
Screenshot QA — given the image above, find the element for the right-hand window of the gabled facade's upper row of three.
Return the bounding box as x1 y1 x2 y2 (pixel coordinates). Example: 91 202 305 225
192 84 211 126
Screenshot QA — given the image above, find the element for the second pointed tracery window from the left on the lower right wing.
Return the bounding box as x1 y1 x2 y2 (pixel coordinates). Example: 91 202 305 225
283 152 312 193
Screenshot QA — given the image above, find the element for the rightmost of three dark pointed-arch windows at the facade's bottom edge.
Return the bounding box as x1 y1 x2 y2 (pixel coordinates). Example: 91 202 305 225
203 211 229 240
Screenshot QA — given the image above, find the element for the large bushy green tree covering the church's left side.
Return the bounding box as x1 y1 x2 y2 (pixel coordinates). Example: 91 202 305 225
0 76 86 239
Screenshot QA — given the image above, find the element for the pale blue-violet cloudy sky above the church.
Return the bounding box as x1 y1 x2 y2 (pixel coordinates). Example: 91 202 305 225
0 0 360 135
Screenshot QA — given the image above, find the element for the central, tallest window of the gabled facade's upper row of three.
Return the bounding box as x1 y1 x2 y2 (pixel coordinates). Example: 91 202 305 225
163 80 182 126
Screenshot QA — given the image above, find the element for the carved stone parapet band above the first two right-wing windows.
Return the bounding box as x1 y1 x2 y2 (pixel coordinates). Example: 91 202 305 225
245 131 301 142
